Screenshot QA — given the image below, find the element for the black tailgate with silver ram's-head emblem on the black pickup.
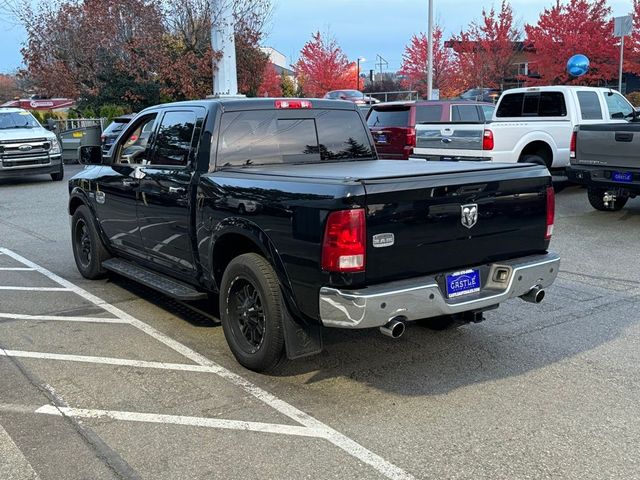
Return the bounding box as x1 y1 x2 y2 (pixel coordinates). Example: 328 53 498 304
363 162 551 284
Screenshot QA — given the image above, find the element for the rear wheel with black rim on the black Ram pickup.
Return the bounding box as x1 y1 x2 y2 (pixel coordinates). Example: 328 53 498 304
220 253 286 372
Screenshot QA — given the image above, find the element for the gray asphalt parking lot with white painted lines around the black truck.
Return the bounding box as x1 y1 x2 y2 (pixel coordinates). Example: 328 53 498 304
0 167 640 480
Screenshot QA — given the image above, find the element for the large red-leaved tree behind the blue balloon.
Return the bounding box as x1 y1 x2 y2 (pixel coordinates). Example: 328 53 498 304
525 0 619 85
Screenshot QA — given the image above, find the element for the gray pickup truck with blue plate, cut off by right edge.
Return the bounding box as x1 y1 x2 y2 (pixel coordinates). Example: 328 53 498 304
567 122 640 211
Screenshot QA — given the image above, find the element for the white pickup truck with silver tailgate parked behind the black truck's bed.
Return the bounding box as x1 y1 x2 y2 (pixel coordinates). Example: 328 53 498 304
410 86 636 168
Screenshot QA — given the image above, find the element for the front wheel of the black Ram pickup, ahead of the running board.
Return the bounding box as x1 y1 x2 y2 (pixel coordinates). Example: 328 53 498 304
71 205 109 280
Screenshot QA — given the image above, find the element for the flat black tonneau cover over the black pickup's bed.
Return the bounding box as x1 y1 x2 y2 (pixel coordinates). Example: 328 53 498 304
224 160 541 181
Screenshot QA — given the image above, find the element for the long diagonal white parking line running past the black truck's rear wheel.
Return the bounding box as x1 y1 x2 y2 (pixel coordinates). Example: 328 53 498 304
0 248 415 480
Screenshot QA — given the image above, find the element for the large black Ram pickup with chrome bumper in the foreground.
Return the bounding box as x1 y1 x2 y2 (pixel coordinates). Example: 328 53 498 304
69 99 559 371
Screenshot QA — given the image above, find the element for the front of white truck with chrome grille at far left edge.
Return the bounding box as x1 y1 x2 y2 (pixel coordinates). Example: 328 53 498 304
0 107 64 181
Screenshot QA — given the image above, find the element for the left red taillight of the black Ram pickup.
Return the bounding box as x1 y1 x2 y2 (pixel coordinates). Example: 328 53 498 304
322 208 367 272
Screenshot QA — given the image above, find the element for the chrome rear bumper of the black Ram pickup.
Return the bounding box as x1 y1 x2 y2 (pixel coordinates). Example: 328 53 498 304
320 252 560 328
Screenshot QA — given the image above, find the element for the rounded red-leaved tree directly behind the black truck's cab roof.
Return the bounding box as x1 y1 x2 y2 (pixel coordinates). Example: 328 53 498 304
295 32 356 97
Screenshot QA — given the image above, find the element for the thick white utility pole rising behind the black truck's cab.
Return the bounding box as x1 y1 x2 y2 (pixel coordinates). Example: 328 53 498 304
211 0 238 96
